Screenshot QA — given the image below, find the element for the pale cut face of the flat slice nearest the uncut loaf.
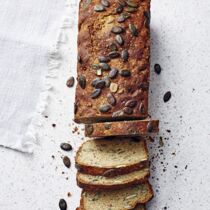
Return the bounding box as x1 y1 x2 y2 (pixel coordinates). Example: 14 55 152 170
76 138 148 168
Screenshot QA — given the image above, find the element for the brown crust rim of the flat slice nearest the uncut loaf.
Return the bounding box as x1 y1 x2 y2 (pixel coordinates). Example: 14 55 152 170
75 141 149 177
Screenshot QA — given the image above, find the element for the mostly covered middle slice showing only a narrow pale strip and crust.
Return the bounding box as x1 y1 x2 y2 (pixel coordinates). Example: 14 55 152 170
77 168 149 191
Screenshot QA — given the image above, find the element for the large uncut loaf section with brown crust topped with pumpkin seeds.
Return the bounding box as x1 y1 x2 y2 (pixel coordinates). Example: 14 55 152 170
75 0 150 123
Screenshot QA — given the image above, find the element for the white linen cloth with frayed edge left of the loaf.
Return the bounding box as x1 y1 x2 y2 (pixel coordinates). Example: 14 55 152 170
0 0 65 152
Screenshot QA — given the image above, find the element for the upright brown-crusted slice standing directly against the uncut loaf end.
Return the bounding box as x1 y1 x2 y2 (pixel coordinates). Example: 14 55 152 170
85 119 159 137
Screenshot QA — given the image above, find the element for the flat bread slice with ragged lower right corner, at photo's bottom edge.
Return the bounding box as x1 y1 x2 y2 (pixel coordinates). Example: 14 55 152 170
81 182 153 210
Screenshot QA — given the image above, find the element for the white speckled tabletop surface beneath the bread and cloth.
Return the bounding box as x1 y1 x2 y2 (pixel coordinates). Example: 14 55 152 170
0 0 210 210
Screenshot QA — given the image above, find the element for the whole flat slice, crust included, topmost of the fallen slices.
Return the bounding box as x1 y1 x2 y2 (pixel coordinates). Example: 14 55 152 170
75 138 148 177
